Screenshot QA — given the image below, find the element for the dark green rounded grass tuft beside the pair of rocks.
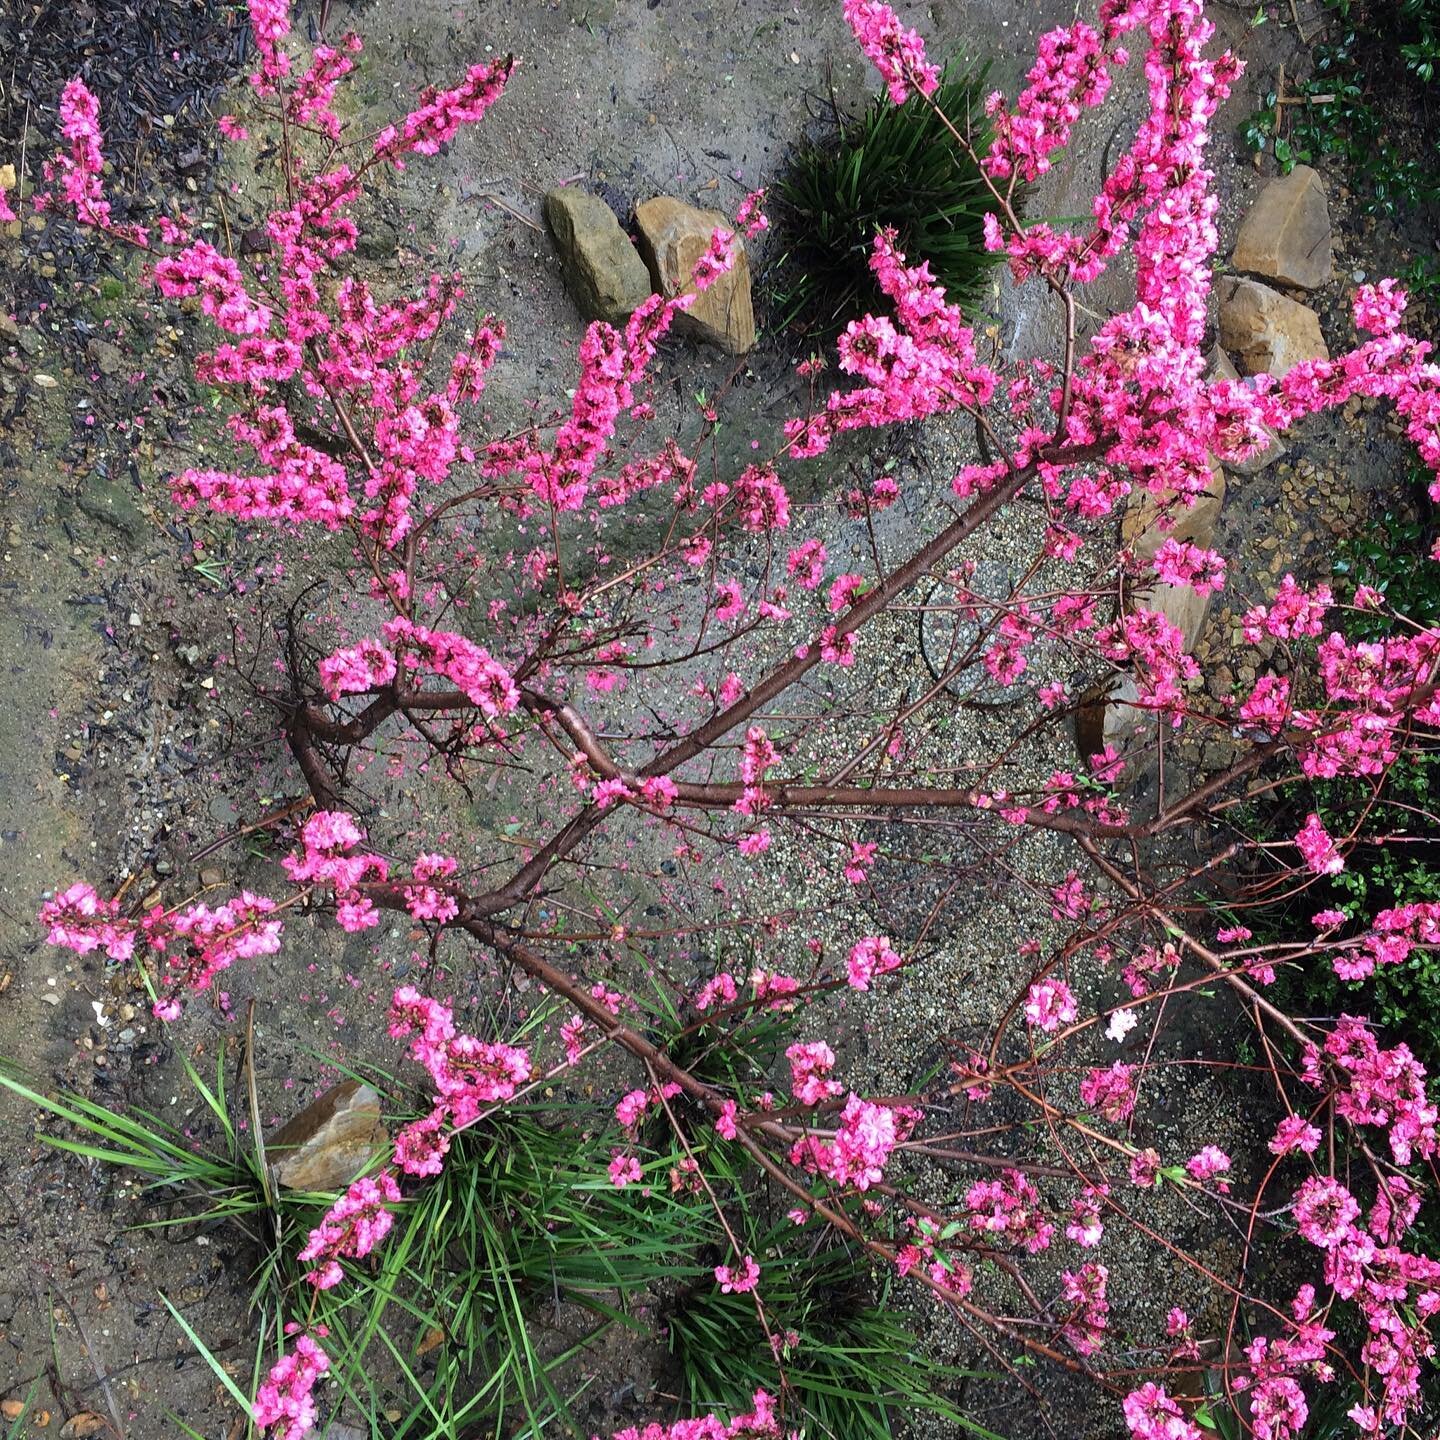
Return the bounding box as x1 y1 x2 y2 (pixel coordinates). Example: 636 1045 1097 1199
772 60 996 343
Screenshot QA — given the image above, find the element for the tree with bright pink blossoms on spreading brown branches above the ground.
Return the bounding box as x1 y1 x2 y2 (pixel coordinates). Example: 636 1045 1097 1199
8 0 1440 1440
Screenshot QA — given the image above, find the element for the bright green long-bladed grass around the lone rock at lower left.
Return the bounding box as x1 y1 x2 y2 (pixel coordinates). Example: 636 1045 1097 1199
0 1061 716 1440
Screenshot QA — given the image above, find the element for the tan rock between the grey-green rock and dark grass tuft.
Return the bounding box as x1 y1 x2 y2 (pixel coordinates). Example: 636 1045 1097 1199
635 194 755 356
